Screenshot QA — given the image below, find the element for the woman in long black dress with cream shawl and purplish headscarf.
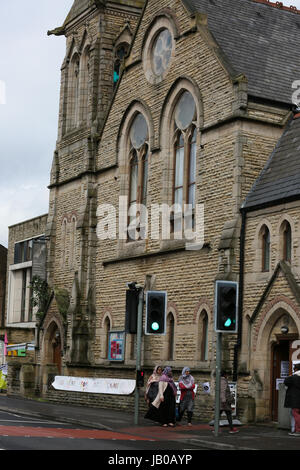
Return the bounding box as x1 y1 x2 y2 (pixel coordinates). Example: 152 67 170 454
145 367 177 427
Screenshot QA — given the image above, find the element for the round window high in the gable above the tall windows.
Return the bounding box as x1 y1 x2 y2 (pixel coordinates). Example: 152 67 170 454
152 29 173 76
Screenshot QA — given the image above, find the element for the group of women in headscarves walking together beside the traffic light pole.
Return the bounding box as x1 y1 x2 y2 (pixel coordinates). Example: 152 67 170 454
145 366 195 427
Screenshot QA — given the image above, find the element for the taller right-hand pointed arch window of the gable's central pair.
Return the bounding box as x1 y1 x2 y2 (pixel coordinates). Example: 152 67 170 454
173 90 197 229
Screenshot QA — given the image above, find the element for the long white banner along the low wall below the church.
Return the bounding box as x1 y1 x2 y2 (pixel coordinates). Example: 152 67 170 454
52 375 135 395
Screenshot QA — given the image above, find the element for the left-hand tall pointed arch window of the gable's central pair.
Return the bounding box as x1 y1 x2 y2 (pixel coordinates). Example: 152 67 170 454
128 113 149 240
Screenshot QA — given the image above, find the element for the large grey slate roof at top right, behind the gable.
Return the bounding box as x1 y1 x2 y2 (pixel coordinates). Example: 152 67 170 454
183 0 300 103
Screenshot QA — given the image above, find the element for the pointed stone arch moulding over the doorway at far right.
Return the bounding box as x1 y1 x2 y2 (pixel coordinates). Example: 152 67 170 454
253 295 300 351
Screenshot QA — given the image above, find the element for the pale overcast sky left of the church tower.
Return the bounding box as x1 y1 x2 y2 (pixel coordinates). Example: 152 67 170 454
0 0 300 246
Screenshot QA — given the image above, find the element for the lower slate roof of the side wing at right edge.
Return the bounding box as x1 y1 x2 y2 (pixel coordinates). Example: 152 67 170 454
242 114 300 210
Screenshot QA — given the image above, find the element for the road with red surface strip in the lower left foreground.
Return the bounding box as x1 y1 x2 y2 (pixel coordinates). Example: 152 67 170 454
0 411 203 456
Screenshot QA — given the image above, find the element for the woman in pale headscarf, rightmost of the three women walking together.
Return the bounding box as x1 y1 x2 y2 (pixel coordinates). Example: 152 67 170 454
178 367 195 426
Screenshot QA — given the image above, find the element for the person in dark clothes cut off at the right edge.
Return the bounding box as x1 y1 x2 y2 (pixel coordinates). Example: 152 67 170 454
284 363 300 436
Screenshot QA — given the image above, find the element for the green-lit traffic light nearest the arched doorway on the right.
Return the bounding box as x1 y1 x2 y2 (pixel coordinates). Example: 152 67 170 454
215 281 238 333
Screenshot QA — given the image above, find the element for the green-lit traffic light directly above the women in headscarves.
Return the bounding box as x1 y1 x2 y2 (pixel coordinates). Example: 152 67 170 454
145 291 167 335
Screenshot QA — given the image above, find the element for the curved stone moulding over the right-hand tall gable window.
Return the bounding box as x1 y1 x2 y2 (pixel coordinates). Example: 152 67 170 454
158 76 204 149
